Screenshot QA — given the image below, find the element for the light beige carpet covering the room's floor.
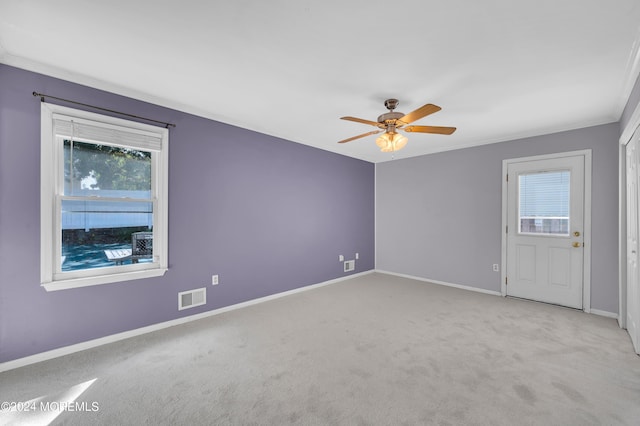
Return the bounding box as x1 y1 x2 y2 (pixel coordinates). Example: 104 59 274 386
0 274 640 425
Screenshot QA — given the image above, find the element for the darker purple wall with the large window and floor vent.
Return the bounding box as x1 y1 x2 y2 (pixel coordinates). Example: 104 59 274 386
0 64 374 362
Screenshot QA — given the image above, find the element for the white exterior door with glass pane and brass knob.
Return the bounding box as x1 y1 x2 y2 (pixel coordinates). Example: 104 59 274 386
505 155 585 309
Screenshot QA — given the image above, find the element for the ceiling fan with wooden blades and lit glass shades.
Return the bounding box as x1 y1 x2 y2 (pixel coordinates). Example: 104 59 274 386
338 99 456 152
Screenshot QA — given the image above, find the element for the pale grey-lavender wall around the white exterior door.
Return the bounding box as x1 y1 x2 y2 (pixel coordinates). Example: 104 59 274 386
376 123 619 313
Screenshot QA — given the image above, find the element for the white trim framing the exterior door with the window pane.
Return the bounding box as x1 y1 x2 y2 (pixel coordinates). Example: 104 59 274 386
500 149 592 313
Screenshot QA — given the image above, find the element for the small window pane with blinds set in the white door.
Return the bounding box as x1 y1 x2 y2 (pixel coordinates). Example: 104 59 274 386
519 170 571 236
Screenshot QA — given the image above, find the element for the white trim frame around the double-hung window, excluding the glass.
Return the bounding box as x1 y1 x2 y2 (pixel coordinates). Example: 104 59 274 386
40 102 169 291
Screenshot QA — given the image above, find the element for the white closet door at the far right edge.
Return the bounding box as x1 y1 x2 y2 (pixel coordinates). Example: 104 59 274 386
626 133 640 353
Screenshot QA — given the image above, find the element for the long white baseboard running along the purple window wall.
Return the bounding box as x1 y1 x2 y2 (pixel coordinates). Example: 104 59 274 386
0 270 375 373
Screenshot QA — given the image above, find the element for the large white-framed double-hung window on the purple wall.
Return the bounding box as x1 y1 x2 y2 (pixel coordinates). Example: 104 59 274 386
40 103 169 291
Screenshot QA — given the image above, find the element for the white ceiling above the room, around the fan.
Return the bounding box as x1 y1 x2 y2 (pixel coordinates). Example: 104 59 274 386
0 0 640 162
